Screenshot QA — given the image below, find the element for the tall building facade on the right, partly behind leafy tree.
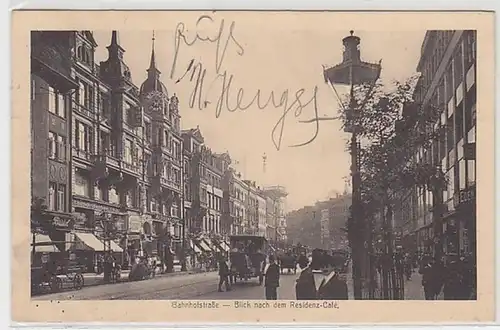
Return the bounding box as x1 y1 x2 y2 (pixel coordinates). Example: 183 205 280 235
395 30 477 258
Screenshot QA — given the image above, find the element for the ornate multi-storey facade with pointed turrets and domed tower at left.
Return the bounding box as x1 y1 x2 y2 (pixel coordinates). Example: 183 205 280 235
31 31 183 268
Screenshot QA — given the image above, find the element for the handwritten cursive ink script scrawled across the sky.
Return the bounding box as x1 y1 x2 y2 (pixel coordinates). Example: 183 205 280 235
170 15 321 150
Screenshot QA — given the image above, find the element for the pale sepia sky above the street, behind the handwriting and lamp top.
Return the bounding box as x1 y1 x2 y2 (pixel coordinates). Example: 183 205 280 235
94 12 425 211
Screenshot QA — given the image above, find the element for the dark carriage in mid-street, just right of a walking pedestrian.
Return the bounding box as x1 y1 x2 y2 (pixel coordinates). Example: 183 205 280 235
229 235 268 285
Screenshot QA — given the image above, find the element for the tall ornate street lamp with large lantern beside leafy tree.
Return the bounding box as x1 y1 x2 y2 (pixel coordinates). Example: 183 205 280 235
323 31 381 299
